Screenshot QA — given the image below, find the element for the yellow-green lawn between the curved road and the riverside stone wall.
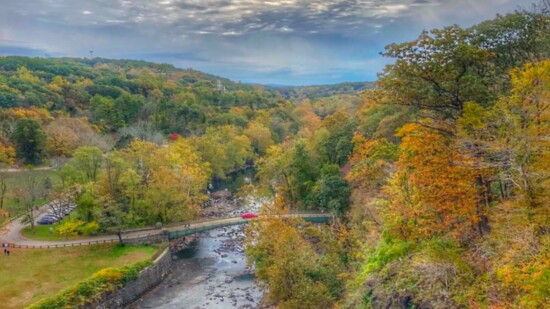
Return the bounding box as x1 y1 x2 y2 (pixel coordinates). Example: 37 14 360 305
0 244 157 309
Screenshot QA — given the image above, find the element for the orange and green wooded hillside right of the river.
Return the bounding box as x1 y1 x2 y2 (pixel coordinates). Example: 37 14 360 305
247 1 550 308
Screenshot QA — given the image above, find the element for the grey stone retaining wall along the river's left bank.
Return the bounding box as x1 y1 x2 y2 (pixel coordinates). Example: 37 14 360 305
83 248 172 309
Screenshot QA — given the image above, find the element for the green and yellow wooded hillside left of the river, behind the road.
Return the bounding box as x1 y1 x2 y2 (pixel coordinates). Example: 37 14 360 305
0 57 361 235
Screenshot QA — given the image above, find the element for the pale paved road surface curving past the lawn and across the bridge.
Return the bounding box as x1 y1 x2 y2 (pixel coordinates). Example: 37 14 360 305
0 213 329 247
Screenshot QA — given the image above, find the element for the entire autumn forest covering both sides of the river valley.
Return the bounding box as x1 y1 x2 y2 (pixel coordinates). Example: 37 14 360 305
0 0 550 308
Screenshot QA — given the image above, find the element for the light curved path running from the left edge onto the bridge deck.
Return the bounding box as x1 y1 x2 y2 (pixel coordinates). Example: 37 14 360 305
0 213 332 248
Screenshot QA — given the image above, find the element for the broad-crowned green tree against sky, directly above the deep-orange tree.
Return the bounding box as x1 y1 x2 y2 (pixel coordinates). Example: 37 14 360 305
378 25 495 120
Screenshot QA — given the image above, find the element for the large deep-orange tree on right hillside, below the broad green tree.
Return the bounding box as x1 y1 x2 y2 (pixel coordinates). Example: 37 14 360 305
386 124 483 239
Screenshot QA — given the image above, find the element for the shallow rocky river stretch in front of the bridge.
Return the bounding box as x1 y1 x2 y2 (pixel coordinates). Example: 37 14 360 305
130 226 263 309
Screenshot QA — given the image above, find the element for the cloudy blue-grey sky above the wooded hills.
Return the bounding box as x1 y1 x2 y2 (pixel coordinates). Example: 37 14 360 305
0 0 532 85
